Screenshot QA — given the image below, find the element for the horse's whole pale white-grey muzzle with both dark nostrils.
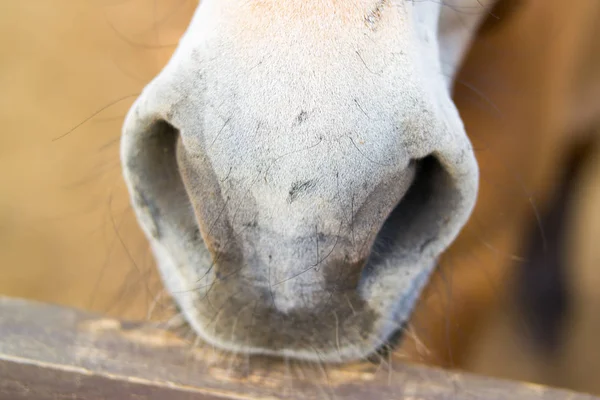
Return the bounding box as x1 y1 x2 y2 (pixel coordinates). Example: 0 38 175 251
121 2 486 360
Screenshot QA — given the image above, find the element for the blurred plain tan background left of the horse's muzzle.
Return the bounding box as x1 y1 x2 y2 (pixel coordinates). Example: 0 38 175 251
0 0 196 318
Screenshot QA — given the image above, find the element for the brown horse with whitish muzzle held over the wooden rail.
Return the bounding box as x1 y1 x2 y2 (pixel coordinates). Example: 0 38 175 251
121 0 600 365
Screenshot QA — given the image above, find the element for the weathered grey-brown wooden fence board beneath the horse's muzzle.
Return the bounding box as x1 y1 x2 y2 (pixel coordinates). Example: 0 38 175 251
0 298 596 400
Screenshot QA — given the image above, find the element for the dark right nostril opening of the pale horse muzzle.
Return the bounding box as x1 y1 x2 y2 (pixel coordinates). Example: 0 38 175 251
362 156 460 278
